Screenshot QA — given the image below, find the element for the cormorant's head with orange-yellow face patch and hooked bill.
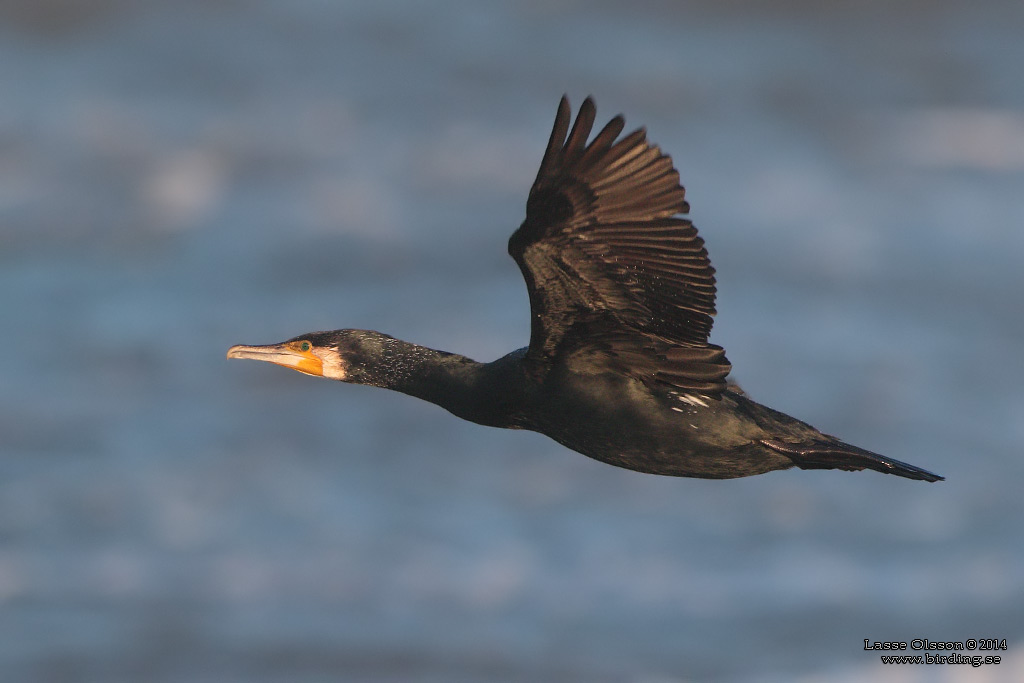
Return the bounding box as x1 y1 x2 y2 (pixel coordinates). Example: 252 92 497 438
227 330 396 384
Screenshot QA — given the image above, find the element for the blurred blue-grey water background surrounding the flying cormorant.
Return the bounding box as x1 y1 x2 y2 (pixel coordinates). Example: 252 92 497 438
0 0 1024 683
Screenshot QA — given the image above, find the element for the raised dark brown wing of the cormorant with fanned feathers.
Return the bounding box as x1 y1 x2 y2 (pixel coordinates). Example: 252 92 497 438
509 97 730 394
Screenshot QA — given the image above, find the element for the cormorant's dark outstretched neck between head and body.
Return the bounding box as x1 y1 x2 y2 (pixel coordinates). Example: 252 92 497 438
353 338 507 426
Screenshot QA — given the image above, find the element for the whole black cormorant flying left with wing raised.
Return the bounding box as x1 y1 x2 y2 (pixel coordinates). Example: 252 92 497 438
227 97 943 481
